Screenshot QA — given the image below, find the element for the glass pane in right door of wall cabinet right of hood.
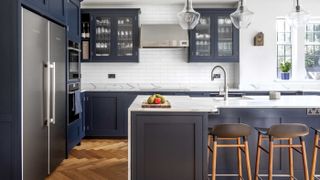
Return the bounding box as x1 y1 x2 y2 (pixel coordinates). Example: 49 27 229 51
217 16 234 56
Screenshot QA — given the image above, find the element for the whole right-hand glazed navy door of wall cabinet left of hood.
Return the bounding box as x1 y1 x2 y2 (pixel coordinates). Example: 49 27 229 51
116 15 139 61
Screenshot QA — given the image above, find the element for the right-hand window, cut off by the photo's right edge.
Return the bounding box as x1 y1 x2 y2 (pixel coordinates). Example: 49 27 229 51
305 22 320 80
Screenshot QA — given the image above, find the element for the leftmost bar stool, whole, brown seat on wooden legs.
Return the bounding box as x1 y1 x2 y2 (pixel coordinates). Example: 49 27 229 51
208 123 252 180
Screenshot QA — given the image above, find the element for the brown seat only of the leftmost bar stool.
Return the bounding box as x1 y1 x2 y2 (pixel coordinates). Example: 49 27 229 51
209 123 252 138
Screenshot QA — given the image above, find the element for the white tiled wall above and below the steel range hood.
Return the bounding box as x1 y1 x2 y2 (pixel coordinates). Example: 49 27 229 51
82 4 239 86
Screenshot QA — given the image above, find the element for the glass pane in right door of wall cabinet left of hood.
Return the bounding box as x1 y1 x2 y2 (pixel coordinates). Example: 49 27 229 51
117 17 134 56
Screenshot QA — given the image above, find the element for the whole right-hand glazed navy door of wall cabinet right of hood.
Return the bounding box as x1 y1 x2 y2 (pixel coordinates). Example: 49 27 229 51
214 14 239 62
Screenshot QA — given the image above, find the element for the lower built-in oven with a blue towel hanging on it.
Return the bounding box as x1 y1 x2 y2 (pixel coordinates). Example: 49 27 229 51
67 82 82 124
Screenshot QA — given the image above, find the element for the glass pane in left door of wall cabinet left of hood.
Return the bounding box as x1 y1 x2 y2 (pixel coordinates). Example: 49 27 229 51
94 16 112 57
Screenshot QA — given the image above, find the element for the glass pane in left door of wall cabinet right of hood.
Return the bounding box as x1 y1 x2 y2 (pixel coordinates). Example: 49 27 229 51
193 16 212 57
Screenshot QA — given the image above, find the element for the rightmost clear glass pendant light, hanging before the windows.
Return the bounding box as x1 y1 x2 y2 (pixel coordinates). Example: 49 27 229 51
286 0 310 28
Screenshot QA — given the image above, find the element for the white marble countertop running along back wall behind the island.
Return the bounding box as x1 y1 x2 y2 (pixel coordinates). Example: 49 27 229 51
81 83 320 92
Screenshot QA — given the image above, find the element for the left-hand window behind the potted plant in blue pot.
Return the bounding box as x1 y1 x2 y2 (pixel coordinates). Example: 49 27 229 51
277 19 292 78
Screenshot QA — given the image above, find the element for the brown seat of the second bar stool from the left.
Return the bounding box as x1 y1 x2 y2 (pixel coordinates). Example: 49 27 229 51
257 123 309 138
